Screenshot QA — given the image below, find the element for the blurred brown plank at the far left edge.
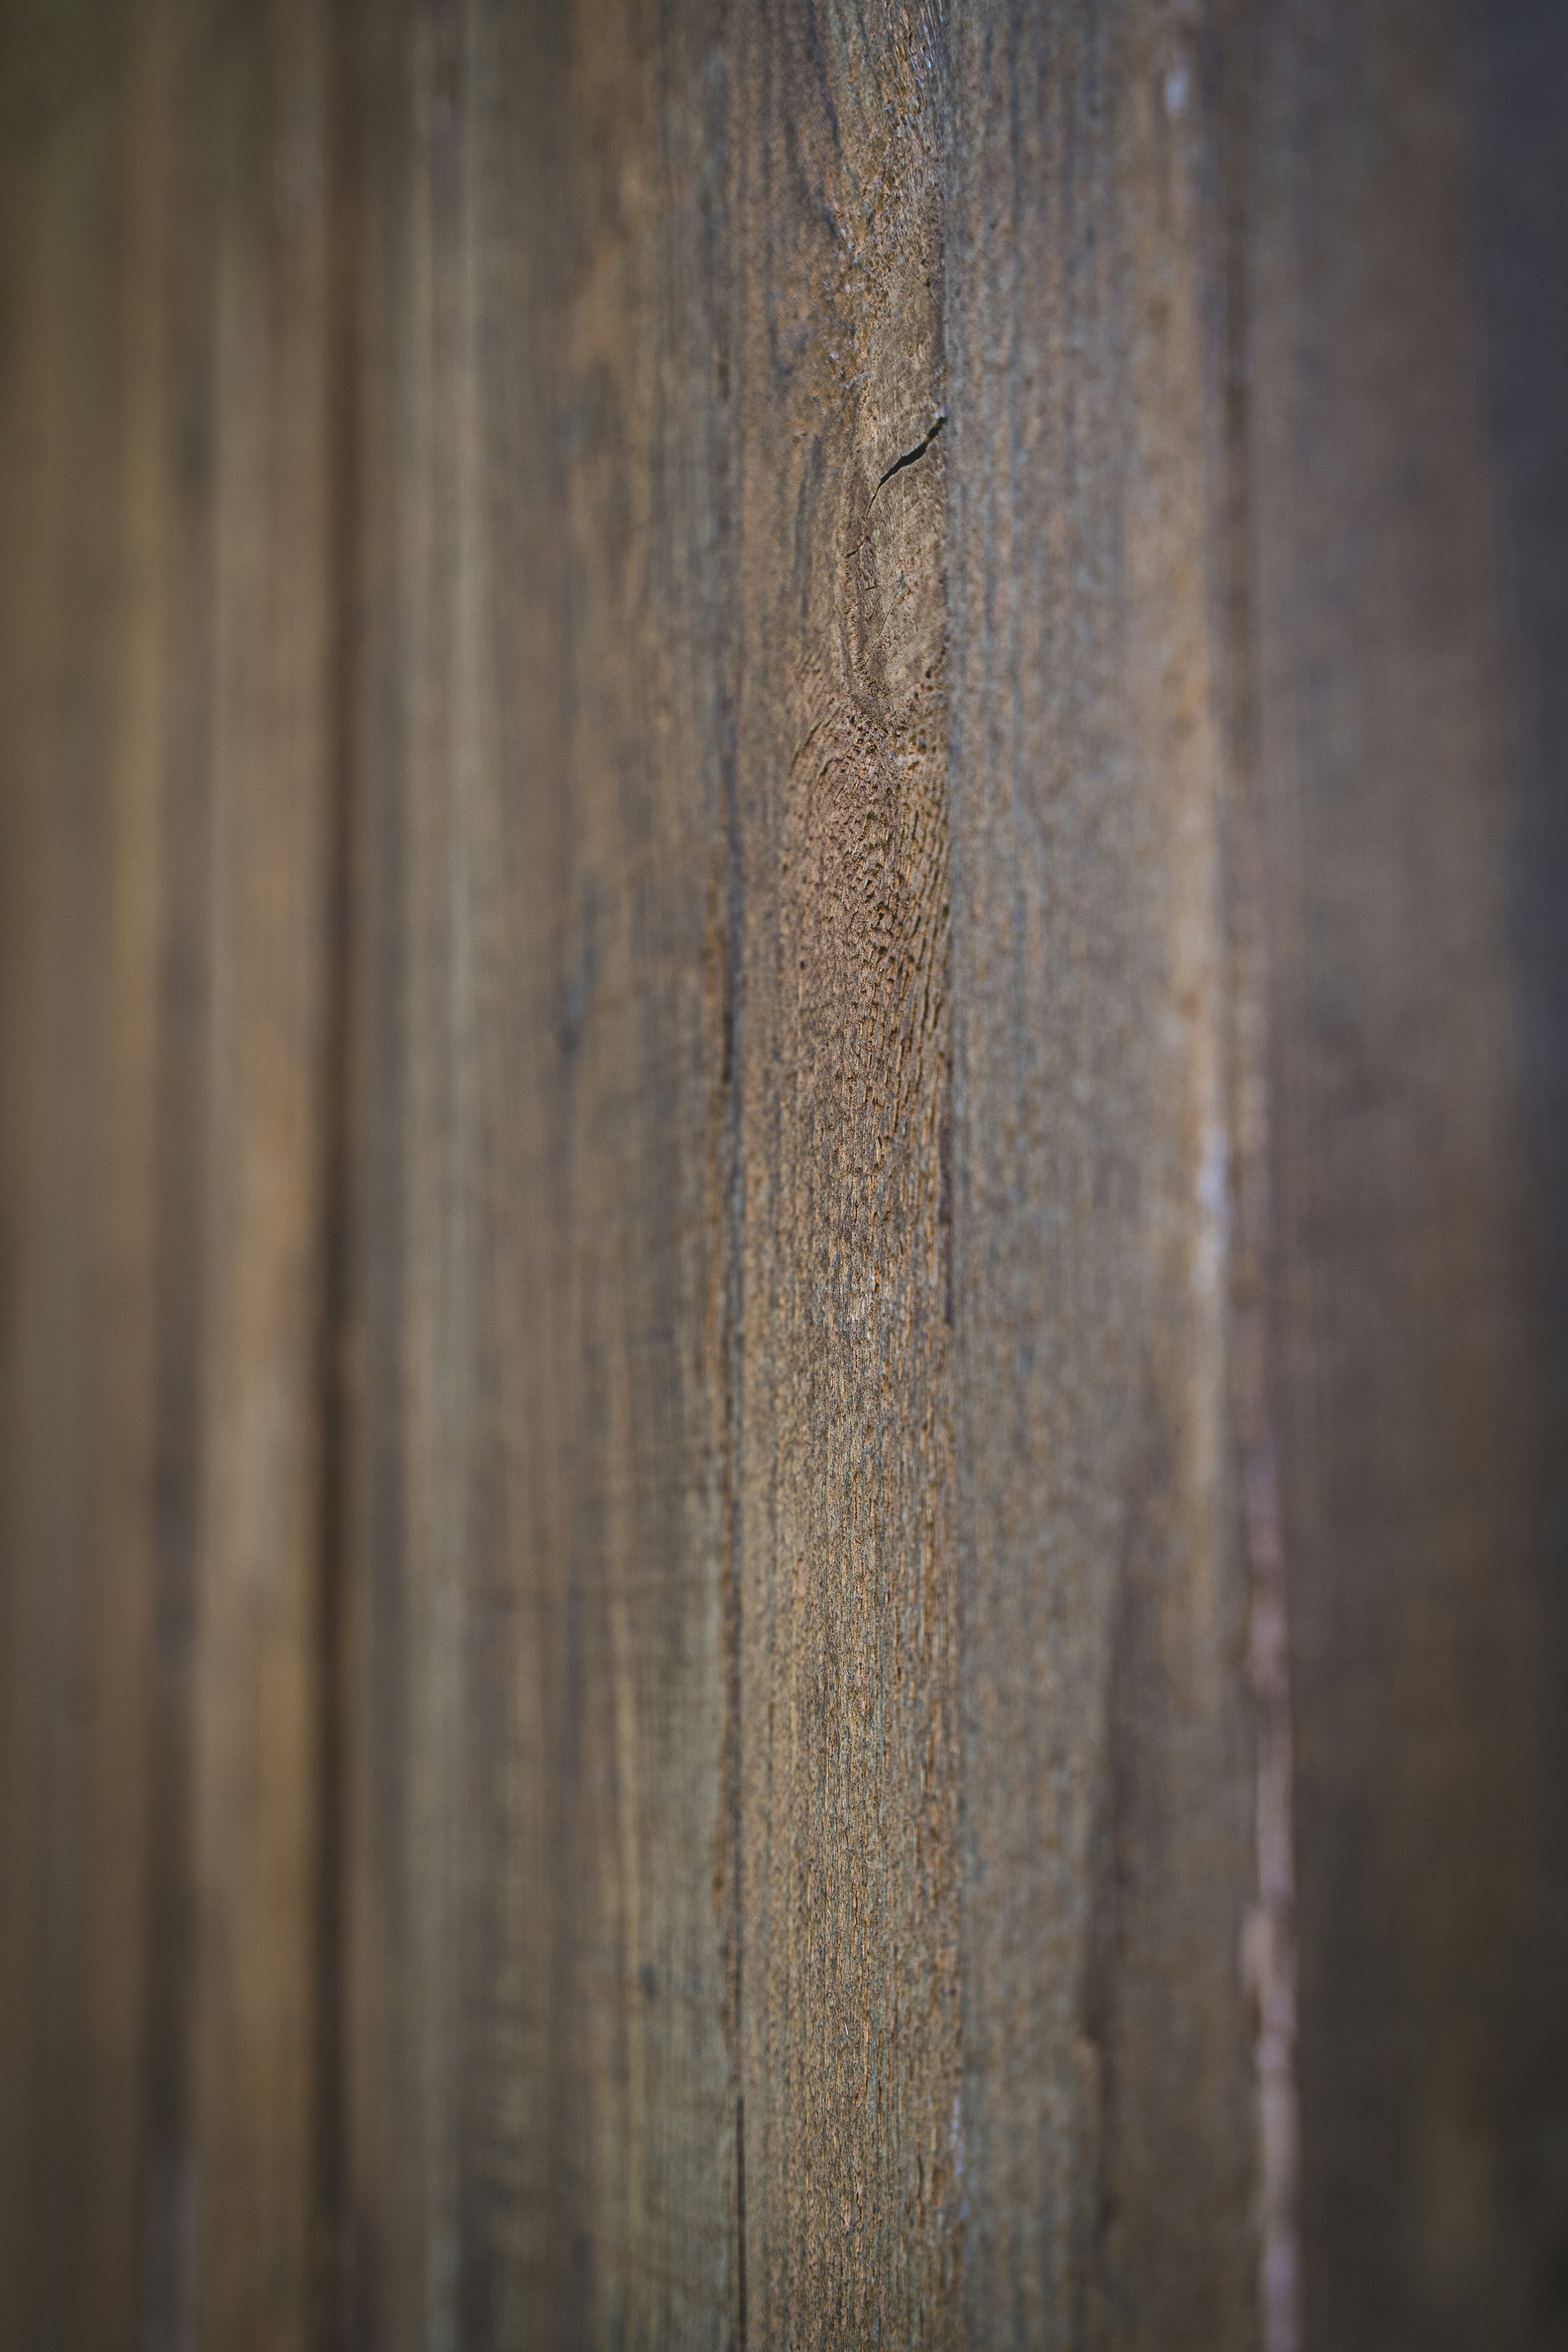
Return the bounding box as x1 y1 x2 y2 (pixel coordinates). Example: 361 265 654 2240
0 12 160 2347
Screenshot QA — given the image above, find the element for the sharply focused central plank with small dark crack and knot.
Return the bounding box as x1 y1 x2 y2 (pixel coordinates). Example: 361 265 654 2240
722 7 962 2343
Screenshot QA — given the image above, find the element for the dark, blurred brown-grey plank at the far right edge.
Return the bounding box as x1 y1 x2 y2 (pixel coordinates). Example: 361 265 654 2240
1248 0 1568 2347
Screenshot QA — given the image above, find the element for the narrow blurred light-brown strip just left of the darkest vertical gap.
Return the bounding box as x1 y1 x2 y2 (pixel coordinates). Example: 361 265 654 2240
191 0 332 2347
